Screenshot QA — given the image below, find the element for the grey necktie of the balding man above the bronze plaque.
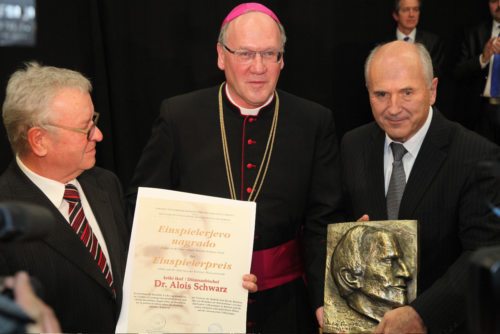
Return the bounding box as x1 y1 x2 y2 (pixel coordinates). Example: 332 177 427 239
386 142 408 220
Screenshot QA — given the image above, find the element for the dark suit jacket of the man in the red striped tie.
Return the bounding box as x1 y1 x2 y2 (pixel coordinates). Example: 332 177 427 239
0 161 129 332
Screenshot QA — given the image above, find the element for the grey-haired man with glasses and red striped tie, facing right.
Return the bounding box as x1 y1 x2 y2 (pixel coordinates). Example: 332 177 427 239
0 63 129 333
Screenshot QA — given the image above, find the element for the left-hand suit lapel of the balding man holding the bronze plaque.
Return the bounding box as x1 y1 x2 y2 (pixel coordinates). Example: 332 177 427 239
366 123 387 220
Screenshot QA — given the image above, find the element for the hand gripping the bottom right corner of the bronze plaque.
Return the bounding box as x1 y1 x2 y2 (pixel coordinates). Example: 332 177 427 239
373 306 427 334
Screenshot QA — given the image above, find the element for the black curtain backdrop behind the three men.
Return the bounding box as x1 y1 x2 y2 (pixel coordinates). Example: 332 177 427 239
0 0 489 186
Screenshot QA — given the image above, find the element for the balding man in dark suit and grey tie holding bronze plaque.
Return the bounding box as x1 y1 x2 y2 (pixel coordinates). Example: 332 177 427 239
341 41 500 333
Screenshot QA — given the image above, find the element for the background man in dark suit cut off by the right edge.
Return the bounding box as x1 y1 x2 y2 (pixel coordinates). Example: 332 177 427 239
455 0 500 144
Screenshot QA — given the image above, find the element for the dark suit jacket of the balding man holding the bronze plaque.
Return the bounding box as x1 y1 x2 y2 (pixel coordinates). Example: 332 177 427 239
341 108 500 333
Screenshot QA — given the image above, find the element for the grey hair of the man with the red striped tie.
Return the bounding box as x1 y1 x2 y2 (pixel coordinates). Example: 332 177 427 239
2 62 92 155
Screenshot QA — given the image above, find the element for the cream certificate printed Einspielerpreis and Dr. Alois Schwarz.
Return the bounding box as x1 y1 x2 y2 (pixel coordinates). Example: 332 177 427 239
116 188 256 333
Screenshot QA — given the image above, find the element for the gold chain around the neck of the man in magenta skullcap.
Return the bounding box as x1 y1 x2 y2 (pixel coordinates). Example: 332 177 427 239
219 82 280 202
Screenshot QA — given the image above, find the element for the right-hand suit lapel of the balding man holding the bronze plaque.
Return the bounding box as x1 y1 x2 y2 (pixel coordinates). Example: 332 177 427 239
399 108 451 219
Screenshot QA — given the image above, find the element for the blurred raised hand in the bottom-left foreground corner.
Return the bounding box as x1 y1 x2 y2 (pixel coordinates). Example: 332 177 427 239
4 271 61 333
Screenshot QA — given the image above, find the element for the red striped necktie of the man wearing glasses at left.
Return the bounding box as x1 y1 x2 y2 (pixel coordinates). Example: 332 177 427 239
63 183 114 290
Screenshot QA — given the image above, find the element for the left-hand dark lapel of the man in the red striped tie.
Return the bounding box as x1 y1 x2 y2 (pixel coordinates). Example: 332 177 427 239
9 162 112 293
